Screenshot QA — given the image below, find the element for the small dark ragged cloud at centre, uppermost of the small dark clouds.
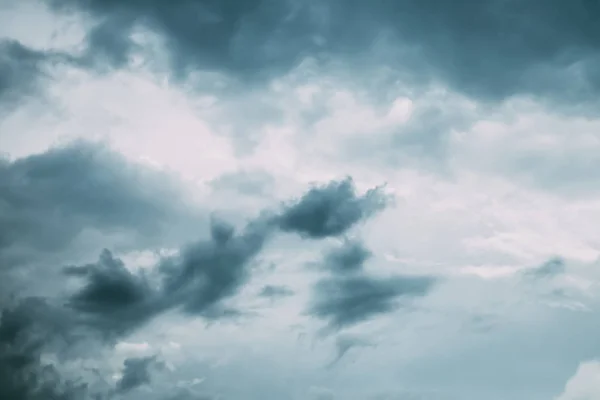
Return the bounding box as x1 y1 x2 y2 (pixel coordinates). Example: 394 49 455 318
279 178 388 239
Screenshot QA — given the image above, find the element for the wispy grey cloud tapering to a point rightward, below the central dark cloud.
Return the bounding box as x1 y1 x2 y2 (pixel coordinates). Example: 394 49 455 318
309 274 436 329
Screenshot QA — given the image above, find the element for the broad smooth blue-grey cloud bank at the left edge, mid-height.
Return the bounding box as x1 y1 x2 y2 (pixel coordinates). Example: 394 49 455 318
0 142 195 274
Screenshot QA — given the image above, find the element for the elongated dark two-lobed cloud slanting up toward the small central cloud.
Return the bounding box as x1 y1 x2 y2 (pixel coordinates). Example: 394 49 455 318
64 216 275 339
